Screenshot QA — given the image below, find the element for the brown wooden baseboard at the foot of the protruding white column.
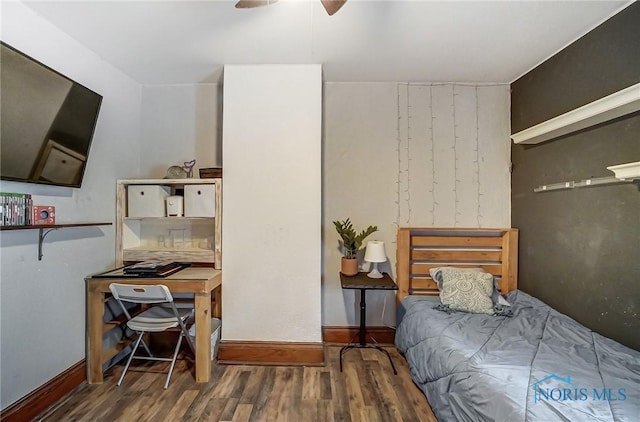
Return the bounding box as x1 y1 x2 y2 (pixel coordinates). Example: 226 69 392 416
218 340 324 366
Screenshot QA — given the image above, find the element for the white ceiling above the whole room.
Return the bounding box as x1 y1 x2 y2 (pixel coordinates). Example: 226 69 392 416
25 0 631 84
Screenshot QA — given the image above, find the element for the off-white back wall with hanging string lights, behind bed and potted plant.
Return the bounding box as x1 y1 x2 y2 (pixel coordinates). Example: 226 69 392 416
322 83 511 326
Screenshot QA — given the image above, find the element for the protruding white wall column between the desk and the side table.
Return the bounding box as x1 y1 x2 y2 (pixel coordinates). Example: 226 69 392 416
222 65 322 343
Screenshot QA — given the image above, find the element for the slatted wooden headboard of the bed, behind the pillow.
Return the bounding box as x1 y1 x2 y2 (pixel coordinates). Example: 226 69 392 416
396 227 518 302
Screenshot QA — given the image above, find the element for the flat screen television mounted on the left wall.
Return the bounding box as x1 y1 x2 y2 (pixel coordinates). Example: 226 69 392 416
0 41 102 188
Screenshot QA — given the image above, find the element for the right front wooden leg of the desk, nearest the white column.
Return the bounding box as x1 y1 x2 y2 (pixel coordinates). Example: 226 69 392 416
195 293 211 382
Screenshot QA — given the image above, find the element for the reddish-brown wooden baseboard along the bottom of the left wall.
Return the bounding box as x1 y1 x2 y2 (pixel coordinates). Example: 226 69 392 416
0 359 87 422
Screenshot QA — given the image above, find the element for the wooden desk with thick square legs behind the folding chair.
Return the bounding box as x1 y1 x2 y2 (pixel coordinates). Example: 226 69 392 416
85 267 222 384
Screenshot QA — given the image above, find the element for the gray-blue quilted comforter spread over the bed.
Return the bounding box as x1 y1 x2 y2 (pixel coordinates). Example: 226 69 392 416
396 291 640 422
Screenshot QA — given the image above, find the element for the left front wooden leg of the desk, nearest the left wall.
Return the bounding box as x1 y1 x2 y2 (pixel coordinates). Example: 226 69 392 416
86 287 104 384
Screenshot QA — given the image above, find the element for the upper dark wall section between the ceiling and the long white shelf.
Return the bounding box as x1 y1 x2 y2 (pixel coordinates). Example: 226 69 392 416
511 2 640 133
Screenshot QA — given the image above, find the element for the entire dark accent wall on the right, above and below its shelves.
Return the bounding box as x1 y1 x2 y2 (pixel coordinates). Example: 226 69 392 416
511 3 640 350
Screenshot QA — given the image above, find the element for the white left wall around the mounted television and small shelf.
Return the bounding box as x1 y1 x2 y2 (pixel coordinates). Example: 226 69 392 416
0 2 141 409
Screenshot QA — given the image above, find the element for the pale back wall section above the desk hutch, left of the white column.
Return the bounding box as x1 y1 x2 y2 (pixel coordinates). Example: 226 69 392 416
139 84 222 178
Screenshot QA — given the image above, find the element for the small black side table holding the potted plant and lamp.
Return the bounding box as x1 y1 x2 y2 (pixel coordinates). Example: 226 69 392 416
340 272 398 374
